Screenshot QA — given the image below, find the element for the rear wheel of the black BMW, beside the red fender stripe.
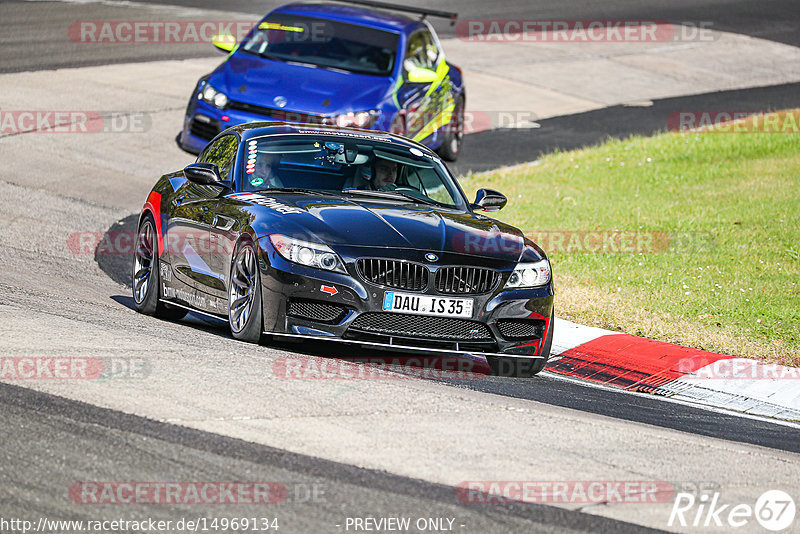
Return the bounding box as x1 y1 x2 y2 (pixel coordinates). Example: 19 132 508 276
131 213 186 321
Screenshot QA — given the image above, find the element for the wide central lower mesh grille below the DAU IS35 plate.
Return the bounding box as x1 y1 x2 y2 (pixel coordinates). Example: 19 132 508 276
349 313 494 341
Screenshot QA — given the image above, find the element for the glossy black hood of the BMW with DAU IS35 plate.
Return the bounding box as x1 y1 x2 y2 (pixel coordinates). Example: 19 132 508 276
244 193 536 261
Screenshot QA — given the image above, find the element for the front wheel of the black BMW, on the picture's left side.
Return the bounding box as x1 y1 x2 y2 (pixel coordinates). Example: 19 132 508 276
228 241 264 343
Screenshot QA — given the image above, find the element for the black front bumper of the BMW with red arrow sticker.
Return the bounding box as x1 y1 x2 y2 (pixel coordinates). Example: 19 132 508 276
260 240 553 358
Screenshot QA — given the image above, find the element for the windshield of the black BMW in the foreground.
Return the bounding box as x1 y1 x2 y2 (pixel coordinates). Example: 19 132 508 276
242 133 466 209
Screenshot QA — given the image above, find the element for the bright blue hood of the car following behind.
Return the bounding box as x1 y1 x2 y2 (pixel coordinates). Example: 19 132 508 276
209 52 391 115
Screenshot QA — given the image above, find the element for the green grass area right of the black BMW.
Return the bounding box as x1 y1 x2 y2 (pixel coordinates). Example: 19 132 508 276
463 111 800 364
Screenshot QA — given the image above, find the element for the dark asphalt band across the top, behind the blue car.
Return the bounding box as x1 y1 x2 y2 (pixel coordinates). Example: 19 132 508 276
0 0 800 72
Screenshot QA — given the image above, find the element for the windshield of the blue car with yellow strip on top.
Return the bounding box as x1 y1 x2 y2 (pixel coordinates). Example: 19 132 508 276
239 15 399 76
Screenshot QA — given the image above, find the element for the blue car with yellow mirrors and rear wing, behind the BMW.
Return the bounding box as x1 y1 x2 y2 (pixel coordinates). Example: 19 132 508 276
178 1 465 161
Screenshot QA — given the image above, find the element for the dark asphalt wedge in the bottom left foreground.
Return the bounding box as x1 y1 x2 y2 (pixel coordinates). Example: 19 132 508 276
0 384 658 533
